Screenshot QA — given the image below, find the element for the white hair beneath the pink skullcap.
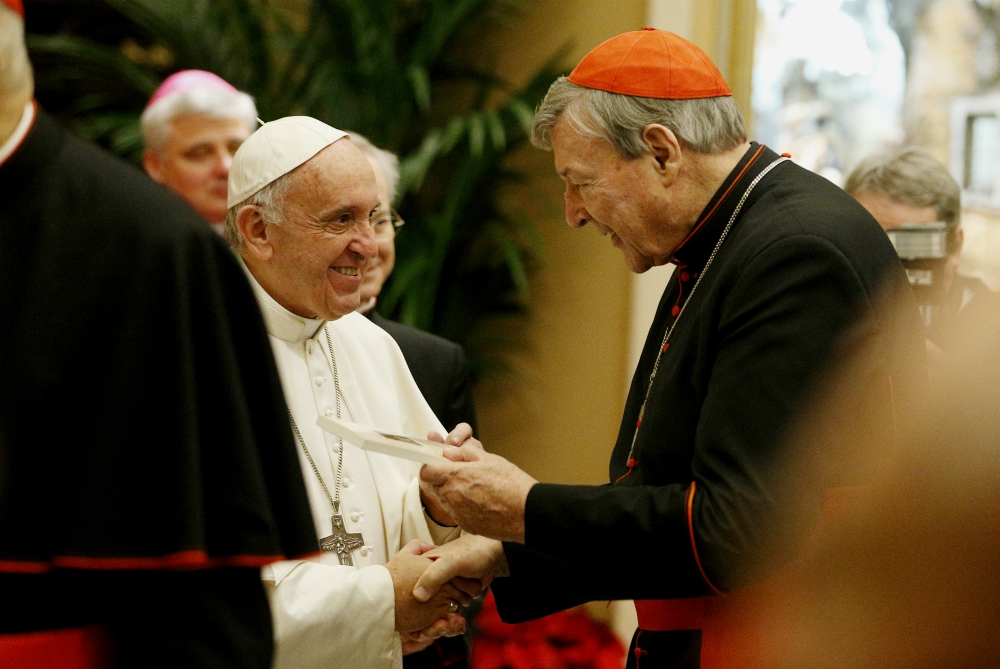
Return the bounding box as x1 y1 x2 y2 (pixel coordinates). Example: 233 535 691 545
140 87 257 153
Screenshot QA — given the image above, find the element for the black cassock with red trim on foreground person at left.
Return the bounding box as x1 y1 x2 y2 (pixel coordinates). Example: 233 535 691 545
0 107 317 667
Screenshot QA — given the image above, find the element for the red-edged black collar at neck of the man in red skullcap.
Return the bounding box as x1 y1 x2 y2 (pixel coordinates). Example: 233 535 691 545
670 142 778 272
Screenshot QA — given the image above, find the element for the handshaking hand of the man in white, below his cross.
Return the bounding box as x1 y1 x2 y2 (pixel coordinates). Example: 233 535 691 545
385 539 482 632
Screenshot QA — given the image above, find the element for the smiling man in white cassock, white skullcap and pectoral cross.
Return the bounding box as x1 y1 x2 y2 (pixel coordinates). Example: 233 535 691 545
226 116 481 669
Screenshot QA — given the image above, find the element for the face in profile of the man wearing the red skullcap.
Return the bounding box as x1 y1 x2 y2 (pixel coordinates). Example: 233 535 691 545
552 120 691 273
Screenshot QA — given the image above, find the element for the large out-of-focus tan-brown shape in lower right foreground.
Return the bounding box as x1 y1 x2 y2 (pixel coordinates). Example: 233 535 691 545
742 312 1000 669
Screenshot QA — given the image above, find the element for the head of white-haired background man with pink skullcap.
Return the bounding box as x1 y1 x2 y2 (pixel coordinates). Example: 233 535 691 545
142 70 257 234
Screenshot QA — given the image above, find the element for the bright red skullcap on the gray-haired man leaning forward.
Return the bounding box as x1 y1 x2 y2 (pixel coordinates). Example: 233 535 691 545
568 28 733 100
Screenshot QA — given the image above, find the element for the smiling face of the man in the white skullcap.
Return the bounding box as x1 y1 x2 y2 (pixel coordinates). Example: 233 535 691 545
266 139 378 320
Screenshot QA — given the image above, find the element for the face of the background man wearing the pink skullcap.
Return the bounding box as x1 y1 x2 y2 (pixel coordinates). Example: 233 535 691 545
143 114 251 223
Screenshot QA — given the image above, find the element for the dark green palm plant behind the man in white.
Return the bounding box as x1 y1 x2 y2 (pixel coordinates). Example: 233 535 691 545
29 0 557 376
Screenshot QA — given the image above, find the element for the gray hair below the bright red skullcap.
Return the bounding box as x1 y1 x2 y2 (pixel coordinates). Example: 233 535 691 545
531 77 747 160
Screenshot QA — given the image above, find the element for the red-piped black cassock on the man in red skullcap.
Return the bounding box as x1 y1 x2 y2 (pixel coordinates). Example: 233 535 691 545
494 144 924 667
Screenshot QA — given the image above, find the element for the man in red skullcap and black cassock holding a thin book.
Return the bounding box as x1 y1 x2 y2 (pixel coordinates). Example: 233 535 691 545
416 29 923 667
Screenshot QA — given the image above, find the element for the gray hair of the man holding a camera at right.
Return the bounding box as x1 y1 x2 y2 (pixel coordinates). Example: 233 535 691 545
844 147 962 235
